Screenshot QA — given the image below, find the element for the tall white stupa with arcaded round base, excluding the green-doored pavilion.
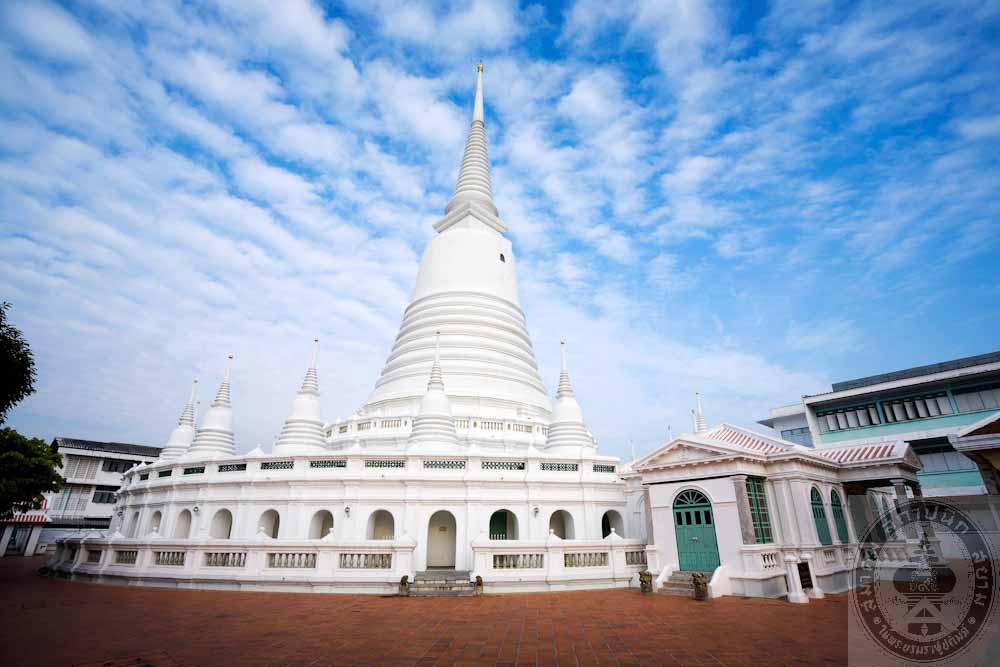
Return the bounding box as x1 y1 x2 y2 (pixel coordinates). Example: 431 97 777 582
47 67 645 592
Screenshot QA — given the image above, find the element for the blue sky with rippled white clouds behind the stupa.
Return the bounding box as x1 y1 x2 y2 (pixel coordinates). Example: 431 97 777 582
0 0 1000 455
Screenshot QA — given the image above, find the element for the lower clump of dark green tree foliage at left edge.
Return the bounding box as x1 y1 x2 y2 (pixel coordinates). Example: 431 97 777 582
0 428 63 521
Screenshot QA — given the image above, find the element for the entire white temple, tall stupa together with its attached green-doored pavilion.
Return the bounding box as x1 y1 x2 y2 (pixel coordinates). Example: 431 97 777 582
52 66 960 602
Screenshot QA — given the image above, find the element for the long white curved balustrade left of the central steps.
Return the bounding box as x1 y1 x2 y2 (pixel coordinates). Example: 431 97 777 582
49 536 416 593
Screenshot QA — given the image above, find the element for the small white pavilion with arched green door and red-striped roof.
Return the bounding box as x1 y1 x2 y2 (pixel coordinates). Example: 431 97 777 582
625 410 921 602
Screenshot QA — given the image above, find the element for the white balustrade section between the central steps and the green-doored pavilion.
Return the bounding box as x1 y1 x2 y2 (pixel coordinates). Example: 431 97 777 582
472 533 646 591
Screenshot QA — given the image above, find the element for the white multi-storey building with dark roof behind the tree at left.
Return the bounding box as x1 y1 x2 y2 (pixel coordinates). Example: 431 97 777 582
0 438 160 556
